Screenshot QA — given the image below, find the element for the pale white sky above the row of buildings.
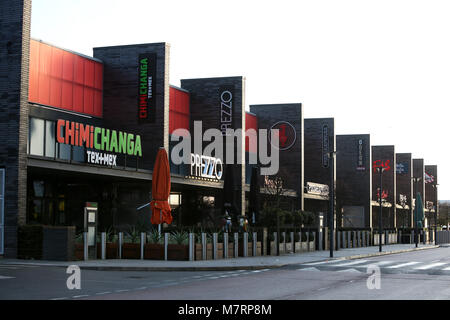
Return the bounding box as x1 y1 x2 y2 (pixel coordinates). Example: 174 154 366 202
31 0 450 199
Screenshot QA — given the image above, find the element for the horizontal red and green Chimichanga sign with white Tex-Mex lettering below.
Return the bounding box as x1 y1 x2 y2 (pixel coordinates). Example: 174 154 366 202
56 119 142 166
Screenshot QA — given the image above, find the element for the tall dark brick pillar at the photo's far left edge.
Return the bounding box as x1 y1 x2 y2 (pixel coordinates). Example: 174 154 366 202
0 0 31 257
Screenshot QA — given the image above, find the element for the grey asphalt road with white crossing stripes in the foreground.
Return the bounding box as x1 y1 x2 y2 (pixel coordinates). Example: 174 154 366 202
0 248 450 300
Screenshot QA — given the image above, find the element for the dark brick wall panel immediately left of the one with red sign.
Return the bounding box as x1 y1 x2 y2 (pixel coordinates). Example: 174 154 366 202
336 134 372 226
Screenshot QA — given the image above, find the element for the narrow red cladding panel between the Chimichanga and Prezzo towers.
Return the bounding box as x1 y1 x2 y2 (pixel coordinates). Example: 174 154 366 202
169 87 190 134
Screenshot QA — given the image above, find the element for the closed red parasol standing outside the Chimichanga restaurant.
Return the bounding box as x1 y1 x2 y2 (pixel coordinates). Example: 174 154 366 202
150 148 172 224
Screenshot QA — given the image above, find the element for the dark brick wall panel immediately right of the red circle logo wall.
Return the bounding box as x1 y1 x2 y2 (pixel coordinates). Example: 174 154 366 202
304 118 335 186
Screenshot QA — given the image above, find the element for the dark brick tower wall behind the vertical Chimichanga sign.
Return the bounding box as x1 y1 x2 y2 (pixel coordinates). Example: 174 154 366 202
94 43 169 170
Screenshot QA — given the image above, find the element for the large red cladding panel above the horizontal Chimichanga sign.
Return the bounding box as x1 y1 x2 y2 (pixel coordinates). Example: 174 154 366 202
28 40 103 117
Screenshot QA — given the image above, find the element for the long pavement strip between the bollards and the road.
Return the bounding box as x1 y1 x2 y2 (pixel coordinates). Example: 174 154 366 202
0 244 439 271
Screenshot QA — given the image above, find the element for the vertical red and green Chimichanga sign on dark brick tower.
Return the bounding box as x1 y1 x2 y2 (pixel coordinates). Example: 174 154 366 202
138 53 156 123
